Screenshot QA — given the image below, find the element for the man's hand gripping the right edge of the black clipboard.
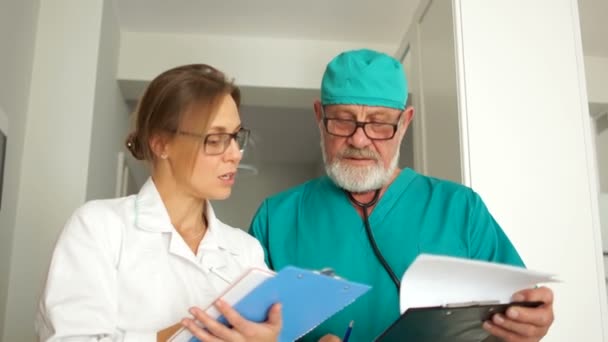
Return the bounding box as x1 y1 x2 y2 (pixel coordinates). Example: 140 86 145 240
483 287 553 342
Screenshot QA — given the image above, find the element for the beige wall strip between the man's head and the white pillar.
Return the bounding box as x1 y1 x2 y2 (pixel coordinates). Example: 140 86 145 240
394 0 462 182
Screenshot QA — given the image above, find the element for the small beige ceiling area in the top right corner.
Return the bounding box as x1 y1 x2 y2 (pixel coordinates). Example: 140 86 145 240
579 0 608 58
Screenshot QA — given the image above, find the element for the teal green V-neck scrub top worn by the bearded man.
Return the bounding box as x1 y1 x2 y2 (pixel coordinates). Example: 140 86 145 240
250 169 524 342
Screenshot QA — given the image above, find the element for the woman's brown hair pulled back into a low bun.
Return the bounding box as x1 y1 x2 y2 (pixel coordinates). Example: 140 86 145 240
126 64 241 161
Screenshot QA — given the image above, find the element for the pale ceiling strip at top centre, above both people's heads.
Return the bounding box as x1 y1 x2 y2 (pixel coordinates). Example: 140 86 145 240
114 0 420 44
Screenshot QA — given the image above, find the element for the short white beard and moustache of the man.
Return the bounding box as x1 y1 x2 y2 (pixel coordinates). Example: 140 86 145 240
321 134 399 193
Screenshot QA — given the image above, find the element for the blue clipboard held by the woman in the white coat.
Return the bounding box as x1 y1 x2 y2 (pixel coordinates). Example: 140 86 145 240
190 266 371 342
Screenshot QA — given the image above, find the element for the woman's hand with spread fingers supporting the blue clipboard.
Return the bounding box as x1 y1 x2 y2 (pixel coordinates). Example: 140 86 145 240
182 300 283 342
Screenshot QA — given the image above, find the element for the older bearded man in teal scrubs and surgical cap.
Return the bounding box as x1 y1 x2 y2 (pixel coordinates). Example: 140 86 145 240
250 50 553 341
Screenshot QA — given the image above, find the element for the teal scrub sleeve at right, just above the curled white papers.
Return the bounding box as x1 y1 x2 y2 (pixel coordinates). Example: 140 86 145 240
468 193 525 267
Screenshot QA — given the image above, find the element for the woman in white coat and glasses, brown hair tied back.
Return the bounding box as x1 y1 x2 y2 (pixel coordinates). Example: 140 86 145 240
36 64 281 341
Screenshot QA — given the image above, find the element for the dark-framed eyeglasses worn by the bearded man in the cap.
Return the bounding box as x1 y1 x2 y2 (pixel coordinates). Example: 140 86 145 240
322 109 403 140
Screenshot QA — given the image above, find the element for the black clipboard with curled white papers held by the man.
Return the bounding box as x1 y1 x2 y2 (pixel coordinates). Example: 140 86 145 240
375 255 555 342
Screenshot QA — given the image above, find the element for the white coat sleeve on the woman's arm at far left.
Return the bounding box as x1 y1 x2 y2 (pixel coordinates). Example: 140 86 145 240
36 205 156 342
